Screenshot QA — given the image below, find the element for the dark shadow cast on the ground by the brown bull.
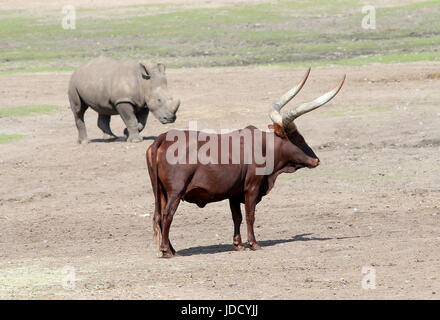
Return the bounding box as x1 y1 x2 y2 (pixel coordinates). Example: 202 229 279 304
177 233 359 256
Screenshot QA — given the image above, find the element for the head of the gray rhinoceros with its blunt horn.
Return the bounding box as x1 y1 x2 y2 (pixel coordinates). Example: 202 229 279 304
141 62 180 124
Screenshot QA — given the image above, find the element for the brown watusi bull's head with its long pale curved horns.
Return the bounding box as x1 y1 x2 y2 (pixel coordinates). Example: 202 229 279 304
269 68 345 168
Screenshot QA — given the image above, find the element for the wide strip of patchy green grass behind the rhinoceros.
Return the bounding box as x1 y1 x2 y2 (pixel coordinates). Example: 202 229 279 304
0 0 440 74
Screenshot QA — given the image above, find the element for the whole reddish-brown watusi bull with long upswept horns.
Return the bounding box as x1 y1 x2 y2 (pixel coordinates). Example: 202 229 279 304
147 68 345 257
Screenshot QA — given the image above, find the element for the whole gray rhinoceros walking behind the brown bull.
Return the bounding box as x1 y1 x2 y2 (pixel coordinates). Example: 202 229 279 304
68 57 180 143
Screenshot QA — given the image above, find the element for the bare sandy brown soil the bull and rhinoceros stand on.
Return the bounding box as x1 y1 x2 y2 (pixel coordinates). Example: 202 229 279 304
0 63 440 299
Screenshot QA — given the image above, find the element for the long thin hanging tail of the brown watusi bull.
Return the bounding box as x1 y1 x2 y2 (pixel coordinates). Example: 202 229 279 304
146 136 163 248
